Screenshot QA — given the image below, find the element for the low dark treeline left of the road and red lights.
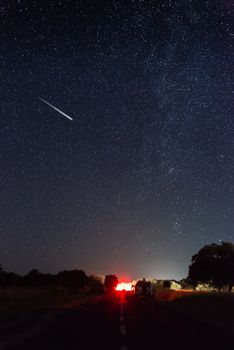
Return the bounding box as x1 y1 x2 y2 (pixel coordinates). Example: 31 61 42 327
0 268 104 293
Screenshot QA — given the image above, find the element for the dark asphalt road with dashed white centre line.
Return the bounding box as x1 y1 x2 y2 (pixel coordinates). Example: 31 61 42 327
5 296 234 350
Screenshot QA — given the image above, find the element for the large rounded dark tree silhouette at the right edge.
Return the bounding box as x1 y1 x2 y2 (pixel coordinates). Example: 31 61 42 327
189 242 234 291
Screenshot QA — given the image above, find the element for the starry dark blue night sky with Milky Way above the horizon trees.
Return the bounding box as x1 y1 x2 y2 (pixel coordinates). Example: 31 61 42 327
0 0 234 279
